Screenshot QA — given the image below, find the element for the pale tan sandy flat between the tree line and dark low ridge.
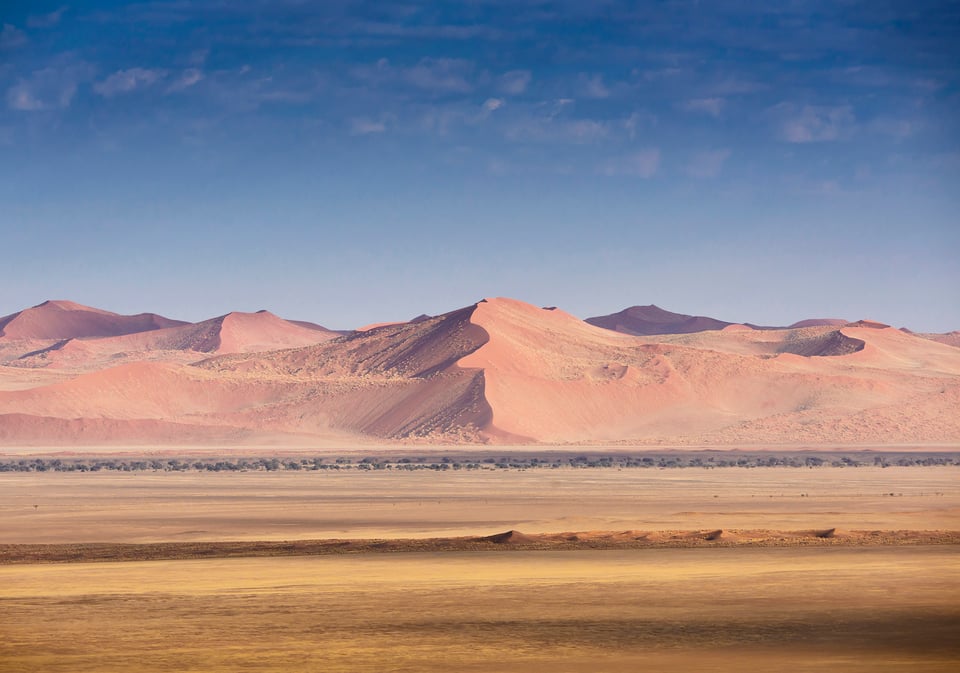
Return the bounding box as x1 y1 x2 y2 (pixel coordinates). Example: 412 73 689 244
0 466 960 543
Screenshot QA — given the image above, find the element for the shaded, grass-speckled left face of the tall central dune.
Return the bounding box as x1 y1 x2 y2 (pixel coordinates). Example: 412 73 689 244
198 306 491 440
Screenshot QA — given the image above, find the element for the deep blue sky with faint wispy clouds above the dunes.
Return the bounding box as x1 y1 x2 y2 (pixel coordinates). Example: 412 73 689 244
0 0 960 331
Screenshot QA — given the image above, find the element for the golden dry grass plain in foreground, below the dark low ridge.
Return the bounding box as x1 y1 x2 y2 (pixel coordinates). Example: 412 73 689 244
0 547 960 673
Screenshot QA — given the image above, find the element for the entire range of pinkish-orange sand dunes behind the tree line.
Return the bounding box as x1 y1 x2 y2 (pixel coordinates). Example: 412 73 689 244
0 298 960 448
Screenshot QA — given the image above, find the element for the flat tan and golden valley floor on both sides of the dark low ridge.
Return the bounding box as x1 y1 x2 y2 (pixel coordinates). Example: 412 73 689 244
0 466 960 673
